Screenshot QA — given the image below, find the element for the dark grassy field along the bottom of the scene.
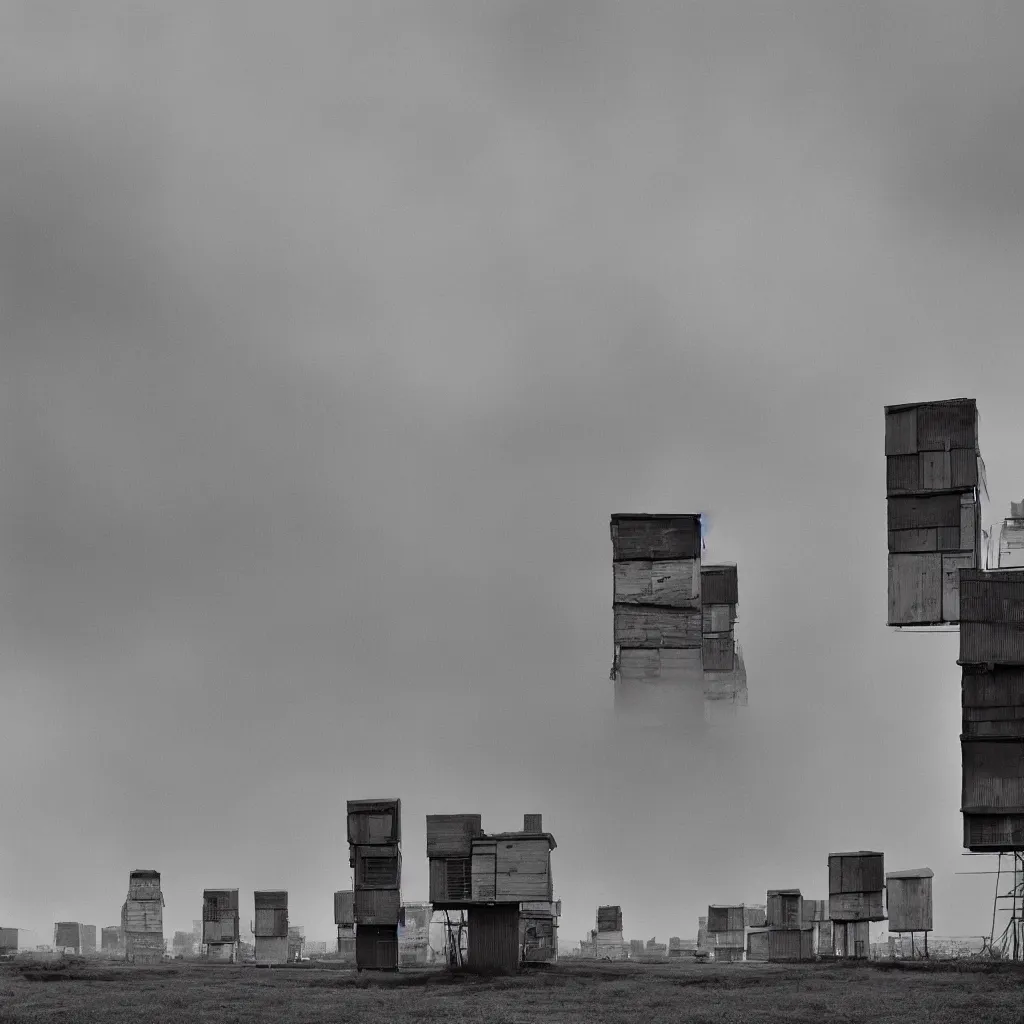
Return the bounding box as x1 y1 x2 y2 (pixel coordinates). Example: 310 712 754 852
0 961 1024 1024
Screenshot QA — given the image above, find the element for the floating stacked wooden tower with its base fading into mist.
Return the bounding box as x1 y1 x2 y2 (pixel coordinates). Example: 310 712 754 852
610 514 746 724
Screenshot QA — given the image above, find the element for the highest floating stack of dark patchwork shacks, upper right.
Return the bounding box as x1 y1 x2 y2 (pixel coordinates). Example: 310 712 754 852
886 398 984 627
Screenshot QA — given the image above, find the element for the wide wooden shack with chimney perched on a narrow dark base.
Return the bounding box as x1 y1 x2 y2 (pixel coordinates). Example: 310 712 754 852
425 814 557 971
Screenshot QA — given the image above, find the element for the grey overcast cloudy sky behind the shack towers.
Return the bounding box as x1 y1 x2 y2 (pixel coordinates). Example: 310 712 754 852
0 0 1024 941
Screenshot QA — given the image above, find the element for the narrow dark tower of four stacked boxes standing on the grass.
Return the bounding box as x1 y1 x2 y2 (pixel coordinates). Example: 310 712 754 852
348 799 401 971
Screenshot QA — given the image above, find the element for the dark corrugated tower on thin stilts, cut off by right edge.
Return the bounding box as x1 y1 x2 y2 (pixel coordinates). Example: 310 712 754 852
959 569 1024 853
